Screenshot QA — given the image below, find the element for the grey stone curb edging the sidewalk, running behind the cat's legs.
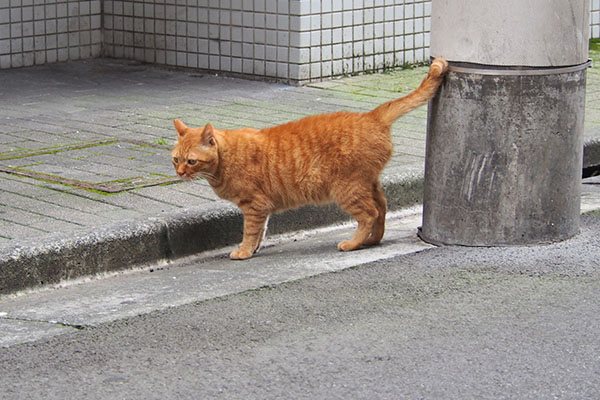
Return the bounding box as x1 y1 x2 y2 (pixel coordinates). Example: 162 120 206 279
0 172 423 295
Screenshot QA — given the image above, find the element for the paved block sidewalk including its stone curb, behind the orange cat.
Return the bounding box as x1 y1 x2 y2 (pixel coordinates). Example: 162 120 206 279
0 59 600 295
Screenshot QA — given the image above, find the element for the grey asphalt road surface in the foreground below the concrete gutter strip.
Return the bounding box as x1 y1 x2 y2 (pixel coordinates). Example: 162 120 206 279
0 216 600 400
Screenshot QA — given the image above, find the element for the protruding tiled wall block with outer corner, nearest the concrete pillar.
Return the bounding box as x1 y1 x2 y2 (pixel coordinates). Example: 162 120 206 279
104 0 431 82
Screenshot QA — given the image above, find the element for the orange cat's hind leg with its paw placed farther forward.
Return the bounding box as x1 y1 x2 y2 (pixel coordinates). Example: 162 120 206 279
335 182 379 251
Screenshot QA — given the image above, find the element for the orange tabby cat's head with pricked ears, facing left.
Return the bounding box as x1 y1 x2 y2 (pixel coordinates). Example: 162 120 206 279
171 119 219 180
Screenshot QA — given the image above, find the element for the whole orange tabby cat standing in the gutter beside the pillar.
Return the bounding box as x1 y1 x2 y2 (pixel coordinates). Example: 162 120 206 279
172 58 448 259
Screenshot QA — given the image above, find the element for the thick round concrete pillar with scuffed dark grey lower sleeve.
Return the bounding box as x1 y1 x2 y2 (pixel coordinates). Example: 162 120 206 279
419 0 589 246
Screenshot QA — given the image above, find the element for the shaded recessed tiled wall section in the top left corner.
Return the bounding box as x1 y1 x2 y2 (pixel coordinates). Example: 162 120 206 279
0 0 102 68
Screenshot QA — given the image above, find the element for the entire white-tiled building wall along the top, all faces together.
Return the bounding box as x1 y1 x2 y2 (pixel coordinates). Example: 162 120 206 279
0 0 600 83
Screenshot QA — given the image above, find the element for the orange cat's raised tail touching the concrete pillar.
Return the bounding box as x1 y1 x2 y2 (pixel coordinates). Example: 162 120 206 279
371 58 448 125
